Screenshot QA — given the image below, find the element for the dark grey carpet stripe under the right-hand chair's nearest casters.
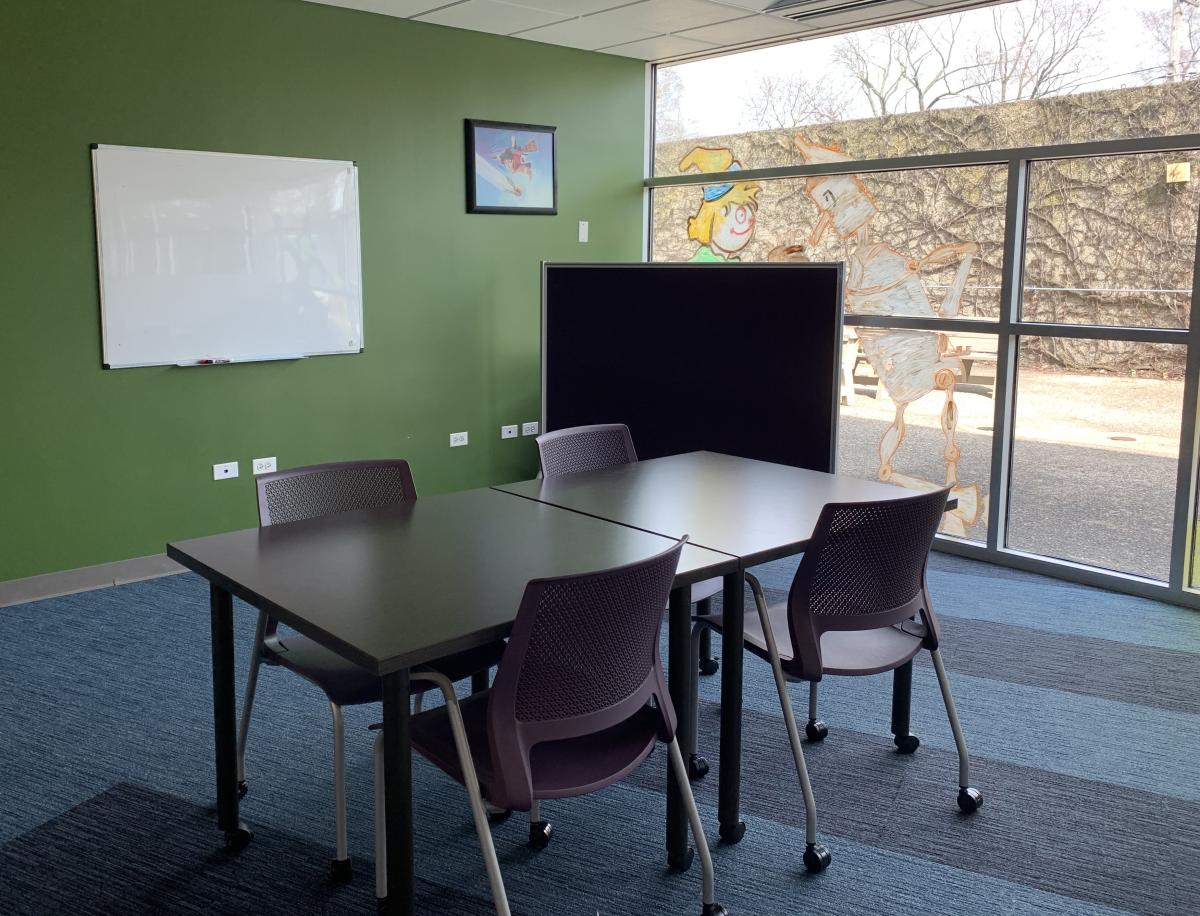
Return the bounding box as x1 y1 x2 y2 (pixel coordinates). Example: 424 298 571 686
630 704 1200 916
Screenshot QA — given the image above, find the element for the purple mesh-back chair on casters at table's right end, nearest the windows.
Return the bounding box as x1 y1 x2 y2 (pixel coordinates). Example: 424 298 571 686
712 489 983 872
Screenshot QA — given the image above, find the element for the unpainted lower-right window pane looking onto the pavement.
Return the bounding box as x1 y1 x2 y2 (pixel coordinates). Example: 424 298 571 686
1008 337 1186 580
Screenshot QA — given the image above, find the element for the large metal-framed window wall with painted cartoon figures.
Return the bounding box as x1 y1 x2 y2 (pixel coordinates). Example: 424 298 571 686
647 0 1200 604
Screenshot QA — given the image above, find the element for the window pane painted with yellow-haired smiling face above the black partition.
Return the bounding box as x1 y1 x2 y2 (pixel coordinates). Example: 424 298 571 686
652 165 1006 318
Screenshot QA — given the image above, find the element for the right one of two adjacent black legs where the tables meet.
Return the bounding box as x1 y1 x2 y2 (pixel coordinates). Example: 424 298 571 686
716 569 746 843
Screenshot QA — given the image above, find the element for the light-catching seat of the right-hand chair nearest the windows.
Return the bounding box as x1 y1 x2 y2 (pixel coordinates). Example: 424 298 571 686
706 601 924 677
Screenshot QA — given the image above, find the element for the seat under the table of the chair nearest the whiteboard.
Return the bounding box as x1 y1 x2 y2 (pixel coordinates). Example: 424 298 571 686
265 634 506 706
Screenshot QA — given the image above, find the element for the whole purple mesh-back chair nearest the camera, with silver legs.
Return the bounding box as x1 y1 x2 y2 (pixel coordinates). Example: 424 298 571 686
376 538 725 916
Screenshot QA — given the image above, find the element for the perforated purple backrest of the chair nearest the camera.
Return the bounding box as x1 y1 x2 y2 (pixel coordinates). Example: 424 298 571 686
500 547 682 723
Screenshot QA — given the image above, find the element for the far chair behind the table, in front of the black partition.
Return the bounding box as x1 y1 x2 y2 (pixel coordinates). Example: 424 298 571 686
538 423 721 779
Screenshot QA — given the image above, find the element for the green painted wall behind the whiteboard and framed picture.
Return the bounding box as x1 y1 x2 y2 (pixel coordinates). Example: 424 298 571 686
0 0 644 580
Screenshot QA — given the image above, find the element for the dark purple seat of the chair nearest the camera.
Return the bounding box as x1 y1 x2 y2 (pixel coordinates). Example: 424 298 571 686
412 690 659 808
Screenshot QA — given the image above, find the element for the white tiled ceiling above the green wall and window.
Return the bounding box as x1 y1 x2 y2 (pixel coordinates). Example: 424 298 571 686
308 0 1007 62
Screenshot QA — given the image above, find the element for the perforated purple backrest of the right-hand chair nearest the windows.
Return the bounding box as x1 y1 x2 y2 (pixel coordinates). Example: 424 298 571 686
793 490 947 617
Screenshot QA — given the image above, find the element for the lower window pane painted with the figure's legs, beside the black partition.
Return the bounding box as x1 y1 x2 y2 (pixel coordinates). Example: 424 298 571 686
838 328 996 541
